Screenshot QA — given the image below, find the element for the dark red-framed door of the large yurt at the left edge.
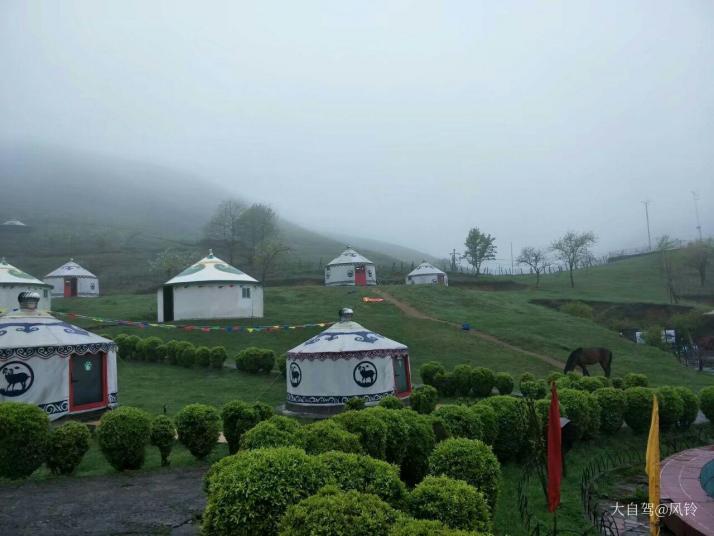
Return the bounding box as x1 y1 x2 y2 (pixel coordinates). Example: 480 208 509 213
69 352 109 413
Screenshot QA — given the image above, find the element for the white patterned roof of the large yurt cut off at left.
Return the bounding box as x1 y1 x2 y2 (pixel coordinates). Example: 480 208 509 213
0 309 115 359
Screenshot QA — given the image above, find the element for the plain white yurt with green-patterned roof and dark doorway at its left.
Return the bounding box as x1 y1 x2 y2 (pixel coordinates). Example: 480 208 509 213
156 250 263 322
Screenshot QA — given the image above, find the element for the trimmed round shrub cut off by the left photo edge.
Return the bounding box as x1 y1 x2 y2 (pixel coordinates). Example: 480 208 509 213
0 402 50 479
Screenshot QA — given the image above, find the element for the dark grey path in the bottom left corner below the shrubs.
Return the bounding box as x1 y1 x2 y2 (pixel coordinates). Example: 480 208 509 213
0 467 207 536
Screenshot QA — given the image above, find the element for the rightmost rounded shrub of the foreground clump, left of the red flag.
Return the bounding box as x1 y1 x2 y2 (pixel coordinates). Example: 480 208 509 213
429 439 501 508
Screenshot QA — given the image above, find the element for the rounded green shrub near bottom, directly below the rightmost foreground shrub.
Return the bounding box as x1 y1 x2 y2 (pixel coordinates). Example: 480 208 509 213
407 476 491 532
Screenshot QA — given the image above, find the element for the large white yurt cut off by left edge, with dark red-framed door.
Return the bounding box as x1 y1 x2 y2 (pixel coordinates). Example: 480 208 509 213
0 292 117 420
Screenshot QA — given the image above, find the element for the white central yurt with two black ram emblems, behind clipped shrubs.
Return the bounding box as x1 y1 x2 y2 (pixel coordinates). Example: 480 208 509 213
285 309 412 414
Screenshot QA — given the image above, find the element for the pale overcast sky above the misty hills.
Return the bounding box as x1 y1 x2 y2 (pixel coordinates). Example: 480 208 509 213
0 0 714 257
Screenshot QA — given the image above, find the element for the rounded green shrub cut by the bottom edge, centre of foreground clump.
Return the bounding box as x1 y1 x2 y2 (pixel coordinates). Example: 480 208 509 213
280 486 403 536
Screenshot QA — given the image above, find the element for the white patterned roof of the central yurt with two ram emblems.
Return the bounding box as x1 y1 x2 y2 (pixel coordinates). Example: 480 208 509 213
288 314 408 360
